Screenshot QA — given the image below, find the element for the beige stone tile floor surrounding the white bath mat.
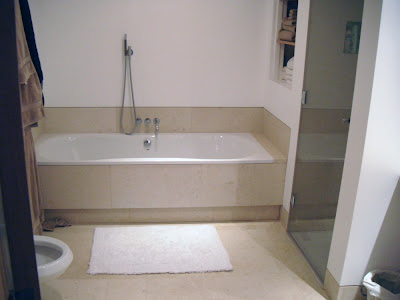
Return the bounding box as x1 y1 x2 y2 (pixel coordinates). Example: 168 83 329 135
41 222 328 300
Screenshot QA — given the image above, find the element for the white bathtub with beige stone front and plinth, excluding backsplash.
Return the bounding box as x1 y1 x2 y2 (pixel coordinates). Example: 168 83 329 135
36 133 286 222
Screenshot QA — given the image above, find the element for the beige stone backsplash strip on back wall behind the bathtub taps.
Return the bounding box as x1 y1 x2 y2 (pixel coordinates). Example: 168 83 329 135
41 107 264 133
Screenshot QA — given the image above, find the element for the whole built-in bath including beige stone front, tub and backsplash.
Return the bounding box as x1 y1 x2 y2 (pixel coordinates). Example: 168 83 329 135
36 107 290 224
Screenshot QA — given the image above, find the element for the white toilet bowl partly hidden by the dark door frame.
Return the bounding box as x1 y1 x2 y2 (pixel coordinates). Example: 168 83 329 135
33 235 73 283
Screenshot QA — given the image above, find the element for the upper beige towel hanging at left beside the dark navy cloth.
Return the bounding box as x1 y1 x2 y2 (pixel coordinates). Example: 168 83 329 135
14 0 44 127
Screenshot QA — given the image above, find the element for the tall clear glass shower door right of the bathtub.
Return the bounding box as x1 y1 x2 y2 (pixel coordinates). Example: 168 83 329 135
288 0 363 281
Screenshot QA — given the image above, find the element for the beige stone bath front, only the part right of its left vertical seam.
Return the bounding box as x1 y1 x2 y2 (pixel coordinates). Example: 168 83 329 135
111 164 285 208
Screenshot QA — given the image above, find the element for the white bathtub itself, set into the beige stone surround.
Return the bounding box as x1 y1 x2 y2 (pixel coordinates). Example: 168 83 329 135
36 133 274 165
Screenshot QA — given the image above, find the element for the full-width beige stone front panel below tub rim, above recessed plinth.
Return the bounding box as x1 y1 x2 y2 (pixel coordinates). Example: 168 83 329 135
39 163 286 209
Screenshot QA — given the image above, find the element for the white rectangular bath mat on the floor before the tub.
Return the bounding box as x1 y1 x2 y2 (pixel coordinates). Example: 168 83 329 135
88 225 232 275
